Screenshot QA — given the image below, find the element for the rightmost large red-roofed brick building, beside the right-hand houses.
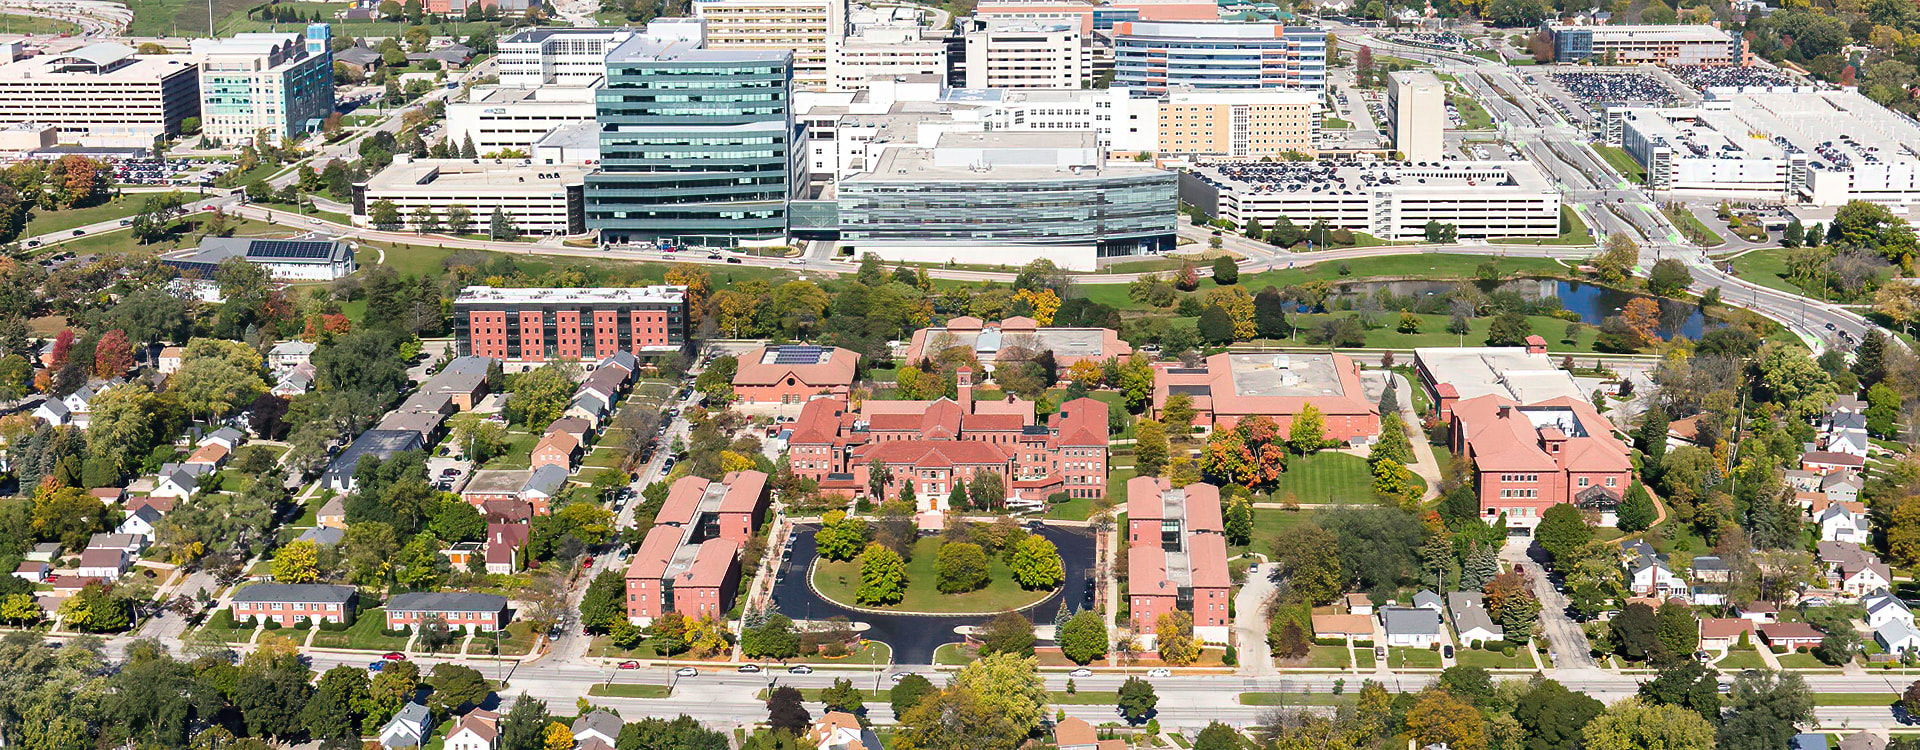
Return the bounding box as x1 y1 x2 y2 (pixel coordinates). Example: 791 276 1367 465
1448 395 1634 533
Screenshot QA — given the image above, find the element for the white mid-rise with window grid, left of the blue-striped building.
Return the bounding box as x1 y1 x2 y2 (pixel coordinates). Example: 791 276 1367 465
966 19 1091 88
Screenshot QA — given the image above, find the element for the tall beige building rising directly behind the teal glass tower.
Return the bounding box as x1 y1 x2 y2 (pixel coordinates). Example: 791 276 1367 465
693 0 847 90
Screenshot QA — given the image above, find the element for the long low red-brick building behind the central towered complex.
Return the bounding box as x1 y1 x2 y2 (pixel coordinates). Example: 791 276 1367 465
904 315 1133 372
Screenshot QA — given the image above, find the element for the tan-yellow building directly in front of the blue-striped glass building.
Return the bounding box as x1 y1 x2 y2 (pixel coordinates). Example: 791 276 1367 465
1158 90 1321 159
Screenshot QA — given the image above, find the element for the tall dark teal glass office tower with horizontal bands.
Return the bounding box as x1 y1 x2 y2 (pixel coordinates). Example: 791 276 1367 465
586 36 806 246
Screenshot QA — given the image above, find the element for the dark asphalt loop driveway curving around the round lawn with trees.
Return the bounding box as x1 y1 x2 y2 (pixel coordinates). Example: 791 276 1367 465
774 524 1094 664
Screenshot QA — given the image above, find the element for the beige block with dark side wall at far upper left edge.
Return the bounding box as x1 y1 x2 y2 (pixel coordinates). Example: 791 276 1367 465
0 42 200 148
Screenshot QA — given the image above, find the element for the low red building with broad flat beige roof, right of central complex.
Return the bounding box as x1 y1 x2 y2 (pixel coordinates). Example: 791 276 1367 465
1154 353 1380 443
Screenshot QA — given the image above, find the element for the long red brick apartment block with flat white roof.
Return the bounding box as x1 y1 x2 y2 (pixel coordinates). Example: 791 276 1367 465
453 286 687 363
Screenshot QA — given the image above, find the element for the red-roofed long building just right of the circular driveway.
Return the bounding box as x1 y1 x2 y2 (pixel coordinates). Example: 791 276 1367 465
1127 476 1233 643
